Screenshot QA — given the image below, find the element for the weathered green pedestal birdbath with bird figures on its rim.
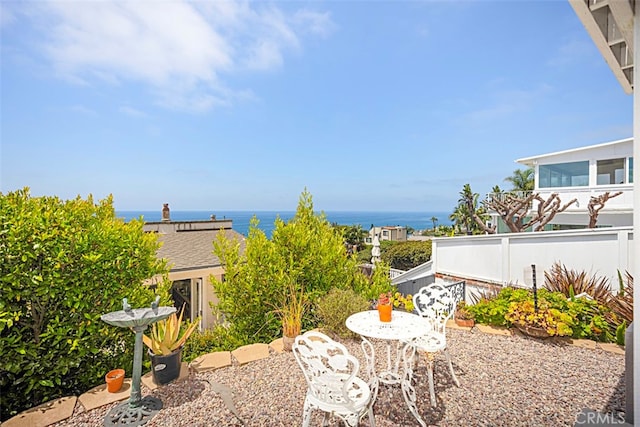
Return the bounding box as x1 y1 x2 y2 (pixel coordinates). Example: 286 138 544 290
100 296 176 426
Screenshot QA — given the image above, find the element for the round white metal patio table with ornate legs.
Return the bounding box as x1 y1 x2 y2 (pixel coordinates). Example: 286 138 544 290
345 310 429 427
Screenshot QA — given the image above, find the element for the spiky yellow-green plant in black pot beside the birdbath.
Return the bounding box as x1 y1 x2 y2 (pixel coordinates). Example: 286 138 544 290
142 305 200 385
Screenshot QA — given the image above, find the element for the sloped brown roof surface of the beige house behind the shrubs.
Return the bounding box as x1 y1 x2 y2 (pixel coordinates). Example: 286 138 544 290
158 229 245 271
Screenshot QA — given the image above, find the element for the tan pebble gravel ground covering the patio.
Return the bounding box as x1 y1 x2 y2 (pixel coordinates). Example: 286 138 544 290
55 330 625 427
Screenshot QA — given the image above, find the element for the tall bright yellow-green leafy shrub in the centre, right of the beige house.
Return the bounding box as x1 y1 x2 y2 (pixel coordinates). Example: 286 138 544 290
211 190 391 343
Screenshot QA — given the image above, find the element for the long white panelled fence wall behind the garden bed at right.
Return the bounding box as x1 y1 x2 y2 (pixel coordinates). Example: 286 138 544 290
432 227 634 288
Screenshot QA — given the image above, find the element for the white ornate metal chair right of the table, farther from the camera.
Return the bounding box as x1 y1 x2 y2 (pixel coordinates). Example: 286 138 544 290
412 283 460 407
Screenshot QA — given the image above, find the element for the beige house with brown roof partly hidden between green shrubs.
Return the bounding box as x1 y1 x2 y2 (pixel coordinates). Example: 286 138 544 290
143 215 245 329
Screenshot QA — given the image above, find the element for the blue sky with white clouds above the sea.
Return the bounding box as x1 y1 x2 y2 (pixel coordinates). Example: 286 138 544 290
0 0 633 212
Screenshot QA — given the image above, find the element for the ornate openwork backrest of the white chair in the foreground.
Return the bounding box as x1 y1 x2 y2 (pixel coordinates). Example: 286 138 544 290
292 331 366 408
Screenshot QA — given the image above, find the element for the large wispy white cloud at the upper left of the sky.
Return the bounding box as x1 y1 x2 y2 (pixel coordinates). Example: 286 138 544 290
33 0 333 111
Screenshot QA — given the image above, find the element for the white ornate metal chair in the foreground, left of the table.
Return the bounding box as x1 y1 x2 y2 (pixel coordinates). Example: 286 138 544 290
292 331 375 427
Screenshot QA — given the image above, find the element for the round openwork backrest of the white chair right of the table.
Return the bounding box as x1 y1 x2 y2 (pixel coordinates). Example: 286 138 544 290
413 283 456 333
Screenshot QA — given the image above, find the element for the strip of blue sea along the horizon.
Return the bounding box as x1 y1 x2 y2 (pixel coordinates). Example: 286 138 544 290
116 209 452 237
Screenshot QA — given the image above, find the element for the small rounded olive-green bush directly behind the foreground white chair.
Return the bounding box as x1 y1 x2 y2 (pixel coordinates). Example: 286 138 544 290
316 288 370 338
